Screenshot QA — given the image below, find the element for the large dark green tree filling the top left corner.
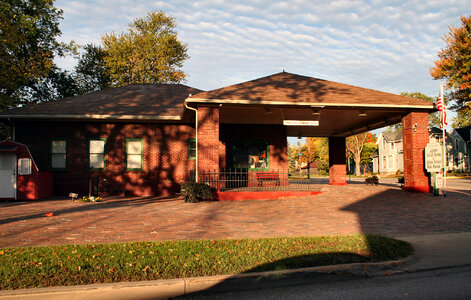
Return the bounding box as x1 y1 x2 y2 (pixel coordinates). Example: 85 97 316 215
0 0 67 110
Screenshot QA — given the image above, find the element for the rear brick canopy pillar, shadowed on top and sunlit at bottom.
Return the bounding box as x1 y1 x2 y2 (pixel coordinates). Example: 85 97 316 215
329 136 347 185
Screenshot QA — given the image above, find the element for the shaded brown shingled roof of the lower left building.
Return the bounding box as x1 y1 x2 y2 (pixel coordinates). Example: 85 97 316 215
0 84 201 120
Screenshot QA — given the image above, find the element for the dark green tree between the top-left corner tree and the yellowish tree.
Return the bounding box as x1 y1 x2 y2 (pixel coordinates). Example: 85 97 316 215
75 44 111 94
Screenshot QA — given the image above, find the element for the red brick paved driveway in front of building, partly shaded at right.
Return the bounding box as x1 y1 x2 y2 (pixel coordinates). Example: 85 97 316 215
0 179 471 247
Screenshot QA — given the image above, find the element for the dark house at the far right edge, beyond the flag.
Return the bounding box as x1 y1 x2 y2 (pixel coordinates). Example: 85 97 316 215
450 126 471 172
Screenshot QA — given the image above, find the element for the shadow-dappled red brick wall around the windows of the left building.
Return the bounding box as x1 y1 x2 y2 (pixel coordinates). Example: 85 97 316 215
16 122 195 195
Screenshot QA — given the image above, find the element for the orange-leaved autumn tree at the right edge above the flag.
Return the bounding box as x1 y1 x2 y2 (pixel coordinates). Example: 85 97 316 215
430 15 471 111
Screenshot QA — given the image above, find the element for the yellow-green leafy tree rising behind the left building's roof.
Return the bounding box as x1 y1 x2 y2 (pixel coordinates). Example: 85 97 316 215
102 11 189 86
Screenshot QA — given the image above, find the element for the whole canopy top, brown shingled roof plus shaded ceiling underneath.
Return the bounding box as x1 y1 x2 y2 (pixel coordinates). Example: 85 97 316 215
186 72 435 136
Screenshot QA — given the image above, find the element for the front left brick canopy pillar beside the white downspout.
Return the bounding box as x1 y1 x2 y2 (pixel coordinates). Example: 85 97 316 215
198 106 221 172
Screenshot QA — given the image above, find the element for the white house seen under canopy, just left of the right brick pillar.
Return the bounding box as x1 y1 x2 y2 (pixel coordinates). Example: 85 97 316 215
372 130 404 173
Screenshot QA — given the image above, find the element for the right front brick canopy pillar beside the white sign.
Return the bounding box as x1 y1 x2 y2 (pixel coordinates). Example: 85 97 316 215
402 112 430 193
